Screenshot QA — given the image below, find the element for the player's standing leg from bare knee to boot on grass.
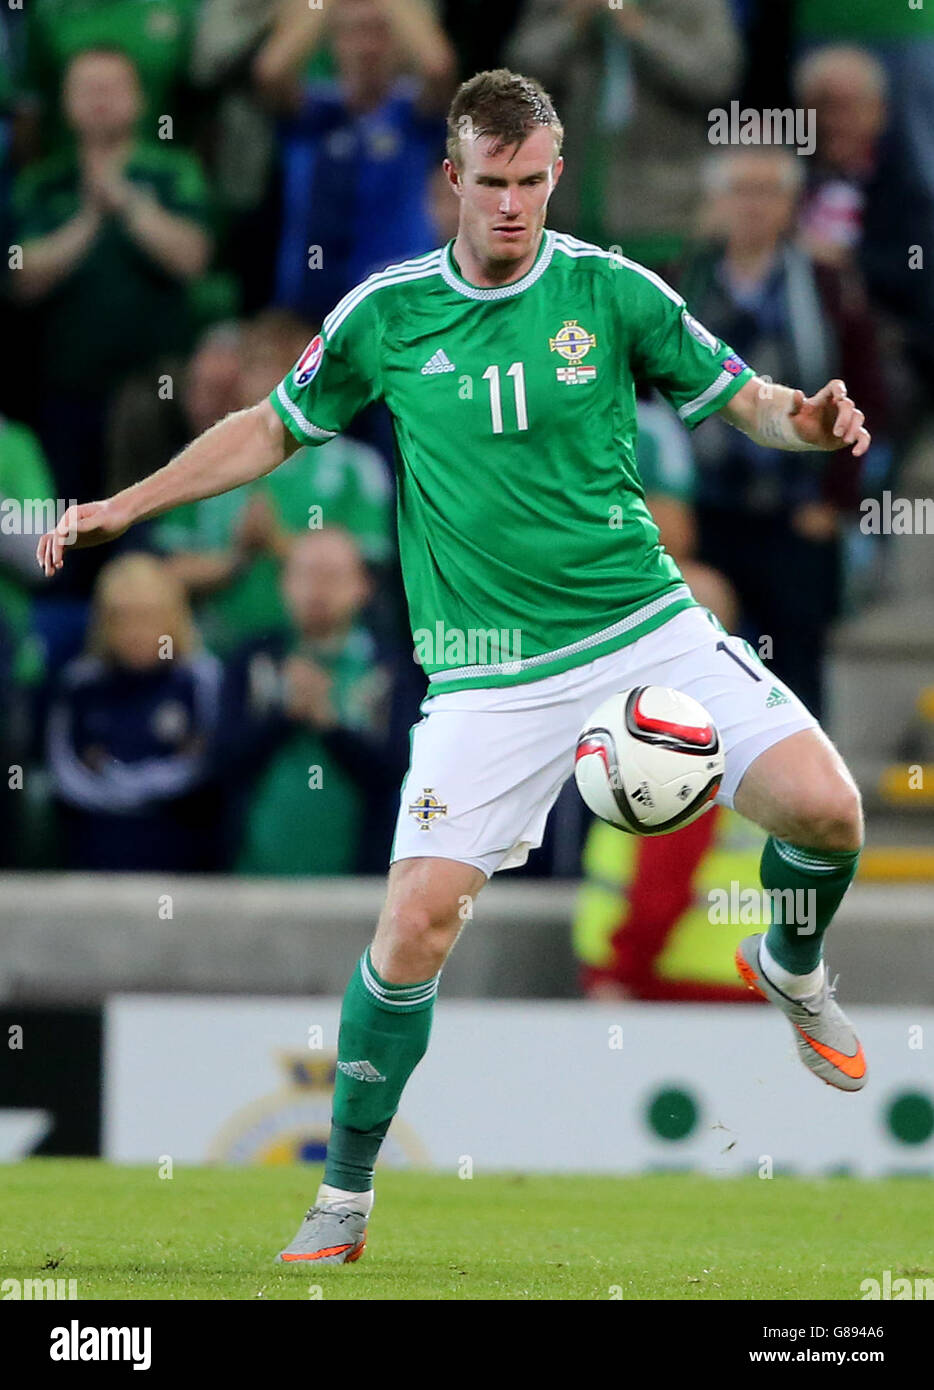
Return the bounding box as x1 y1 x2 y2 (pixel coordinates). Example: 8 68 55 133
278 858 486 1265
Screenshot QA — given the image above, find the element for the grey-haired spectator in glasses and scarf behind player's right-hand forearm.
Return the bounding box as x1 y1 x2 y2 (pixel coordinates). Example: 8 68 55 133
680 147 885 717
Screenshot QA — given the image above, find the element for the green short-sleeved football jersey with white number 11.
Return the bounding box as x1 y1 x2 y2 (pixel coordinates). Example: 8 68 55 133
270 231 752 706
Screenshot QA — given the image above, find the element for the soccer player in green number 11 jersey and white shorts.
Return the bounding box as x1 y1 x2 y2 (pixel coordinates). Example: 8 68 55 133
38 70 869 1264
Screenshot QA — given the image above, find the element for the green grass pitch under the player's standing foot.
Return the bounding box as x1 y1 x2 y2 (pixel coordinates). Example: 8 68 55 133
0 1159 934 1300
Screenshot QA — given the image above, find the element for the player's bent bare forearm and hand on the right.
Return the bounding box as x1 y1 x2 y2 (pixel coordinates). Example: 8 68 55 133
720 377 871 459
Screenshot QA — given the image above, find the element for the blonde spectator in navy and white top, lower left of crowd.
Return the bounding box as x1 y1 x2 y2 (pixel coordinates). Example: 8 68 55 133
47 555 221 873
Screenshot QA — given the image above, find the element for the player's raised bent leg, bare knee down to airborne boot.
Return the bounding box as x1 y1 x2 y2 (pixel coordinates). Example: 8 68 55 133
735 728 866 1091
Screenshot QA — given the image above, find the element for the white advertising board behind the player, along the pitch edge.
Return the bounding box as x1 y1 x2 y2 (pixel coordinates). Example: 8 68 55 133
104 995 934 1176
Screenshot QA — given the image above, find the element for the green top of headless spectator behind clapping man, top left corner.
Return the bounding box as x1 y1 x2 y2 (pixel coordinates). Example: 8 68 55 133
14 0 199 157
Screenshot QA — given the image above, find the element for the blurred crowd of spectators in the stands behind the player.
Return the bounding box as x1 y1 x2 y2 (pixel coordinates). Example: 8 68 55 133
0 0 934 874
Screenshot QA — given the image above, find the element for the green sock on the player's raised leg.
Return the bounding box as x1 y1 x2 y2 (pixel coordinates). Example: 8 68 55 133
759 835 859 974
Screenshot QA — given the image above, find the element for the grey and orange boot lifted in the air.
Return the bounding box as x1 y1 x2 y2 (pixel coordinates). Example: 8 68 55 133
737 935 866 1091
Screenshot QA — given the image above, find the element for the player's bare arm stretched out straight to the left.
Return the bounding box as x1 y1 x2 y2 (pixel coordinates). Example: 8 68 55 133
36 400 297 575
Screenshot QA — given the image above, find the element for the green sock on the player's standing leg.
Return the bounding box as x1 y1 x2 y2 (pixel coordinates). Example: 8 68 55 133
324 948 441 1193
